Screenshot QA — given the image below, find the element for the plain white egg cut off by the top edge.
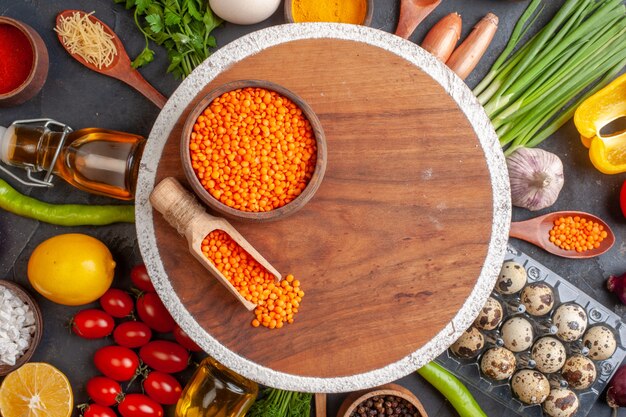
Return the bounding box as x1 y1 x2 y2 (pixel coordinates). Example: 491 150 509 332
209 0 280 25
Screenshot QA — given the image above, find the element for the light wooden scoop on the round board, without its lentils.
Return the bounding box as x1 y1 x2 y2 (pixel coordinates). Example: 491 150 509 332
150 177 282 310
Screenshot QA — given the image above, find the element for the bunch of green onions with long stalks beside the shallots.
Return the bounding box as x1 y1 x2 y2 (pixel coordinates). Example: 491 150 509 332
474 0 626 155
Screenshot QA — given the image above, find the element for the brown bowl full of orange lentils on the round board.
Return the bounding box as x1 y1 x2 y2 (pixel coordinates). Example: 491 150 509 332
181 80 327 222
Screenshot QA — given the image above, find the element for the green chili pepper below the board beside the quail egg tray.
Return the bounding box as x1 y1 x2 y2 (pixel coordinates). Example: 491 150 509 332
417 362 487 417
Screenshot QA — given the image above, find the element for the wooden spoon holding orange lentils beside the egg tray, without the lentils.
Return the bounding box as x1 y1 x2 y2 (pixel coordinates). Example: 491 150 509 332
509 211 615 259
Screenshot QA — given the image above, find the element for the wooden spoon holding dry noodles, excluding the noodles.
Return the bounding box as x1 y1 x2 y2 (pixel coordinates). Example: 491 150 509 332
56 10 167 109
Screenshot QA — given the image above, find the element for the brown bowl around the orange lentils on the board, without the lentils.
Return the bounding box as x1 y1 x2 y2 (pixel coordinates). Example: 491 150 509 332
180 80 327 222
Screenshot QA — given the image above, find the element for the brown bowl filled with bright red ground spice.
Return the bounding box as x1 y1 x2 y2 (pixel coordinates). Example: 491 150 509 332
0 16 49 107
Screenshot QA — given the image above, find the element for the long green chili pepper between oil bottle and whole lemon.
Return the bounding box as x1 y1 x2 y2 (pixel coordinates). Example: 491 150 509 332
0 179 135 226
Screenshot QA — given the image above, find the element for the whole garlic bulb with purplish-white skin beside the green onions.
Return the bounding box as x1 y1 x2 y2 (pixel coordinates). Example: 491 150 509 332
506 148 564 211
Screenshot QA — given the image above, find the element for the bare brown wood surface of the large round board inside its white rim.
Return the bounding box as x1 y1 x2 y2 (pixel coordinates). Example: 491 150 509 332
154 39 492 377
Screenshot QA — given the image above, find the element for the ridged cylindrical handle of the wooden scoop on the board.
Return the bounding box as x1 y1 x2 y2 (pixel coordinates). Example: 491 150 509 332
150 177 212 235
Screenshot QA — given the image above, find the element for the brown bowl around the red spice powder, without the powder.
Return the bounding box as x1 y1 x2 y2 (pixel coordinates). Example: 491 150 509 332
0 16 48 107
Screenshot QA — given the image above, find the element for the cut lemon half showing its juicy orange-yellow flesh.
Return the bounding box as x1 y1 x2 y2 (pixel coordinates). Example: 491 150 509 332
0 363 74 417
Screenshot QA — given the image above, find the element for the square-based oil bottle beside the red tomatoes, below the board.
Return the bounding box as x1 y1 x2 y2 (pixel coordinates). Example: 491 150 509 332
176 357 259 417
